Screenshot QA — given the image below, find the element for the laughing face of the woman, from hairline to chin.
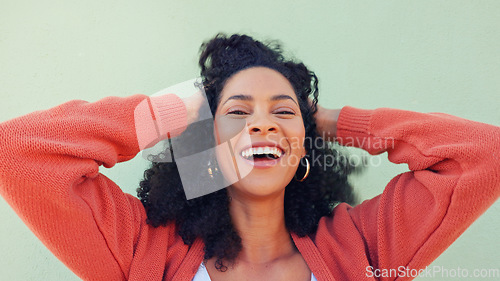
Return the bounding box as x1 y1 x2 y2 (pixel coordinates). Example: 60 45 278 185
214 67 306 197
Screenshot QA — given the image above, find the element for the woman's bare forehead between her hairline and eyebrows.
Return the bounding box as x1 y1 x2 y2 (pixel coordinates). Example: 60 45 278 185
220 67 297 102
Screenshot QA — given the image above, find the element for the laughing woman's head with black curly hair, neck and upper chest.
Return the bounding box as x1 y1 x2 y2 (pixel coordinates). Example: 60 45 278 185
139 35 354 280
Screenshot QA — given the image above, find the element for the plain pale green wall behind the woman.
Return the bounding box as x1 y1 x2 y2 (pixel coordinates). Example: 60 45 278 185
0 0 500 280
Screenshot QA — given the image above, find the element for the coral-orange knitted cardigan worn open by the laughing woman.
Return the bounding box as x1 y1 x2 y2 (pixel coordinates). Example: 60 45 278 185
0 95 500 281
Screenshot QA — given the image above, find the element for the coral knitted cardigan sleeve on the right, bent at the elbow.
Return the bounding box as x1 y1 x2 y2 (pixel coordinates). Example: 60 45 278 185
326 107 500 280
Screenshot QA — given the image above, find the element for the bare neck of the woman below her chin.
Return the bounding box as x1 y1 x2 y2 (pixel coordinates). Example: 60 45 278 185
229 188 296 264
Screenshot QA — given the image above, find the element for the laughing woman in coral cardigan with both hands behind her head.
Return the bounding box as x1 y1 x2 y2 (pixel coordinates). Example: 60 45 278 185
0 35 500 280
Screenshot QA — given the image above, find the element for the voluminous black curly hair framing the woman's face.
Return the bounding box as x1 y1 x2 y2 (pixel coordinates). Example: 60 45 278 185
137 34 355 271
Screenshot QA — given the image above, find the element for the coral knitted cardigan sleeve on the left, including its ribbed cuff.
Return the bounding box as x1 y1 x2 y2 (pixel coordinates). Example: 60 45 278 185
0 95 186 280
